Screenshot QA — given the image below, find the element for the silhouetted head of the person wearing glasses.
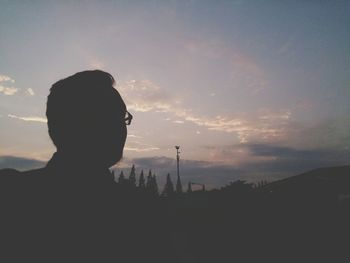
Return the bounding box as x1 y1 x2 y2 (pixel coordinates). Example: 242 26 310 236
46 70 131 167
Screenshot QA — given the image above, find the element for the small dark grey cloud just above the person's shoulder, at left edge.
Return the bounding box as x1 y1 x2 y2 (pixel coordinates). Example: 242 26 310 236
0 156 46 171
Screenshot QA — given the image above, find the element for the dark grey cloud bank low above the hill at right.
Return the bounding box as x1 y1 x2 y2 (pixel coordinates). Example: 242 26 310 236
201 144 350 181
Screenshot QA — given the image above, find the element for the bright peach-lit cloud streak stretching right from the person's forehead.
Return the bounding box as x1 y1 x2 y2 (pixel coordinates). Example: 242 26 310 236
119 80 291 143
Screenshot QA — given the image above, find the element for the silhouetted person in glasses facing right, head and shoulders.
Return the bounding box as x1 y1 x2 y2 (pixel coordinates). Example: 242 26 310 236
0 70 163 262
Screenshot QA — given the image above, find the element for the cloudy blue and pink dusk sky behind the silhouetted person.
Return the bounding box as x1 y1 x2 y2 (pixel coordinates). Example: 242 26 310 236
0 0 350 187
